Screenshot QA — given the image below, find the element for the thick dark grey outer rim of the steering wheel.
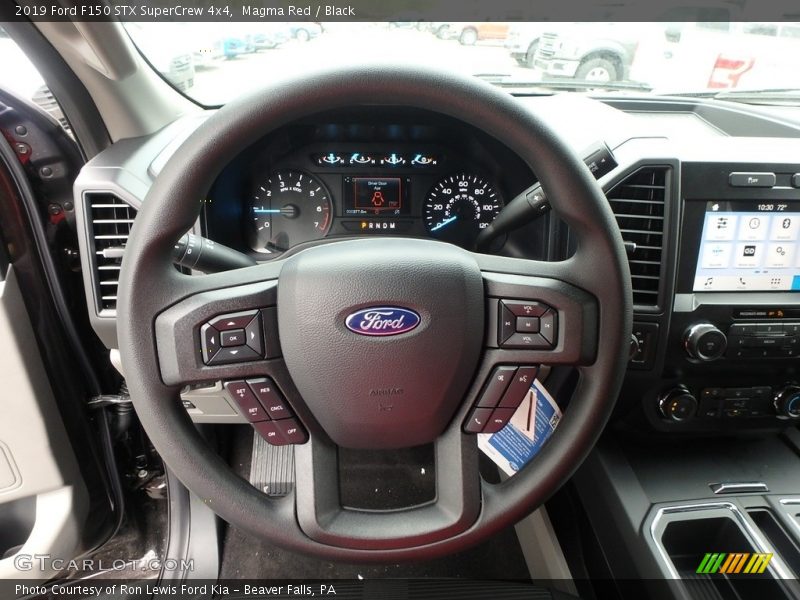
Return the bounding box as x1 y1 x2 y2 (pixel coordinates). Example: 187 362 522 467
117 66 632 562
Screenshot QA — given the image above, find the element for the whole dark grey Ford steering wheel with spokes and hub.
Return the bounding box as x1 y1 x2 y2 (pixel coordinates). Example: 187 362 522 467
117 66 632 562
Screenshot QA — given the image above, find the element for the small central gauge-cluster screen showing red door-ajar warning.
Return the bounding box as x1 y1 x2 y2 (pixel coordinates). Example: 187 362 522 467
344 177 409 217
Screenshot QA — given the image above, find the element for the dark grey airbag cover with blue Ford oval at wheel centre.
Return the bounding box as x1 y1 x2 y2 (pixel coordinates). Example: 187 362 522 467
278 239 484 449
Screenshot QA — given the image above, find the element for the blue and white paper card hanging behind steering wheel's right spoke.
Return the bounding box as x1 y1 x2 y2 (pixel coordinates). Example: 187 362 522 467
478 379 561 475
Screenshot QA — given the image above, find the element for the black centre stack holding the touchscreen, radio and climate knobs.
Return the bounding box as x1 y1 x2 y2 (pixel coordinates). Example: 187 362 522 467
644 162 800 432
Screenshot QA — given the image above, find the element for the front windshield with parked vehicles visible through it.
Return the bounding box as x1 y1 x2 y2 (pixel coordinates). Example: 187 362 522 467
126 20 800 105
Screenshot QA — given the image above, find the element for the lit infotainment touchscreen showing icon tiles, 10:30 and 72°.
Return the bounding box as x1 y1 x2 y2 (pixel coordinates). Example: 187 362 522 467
693 201 800 292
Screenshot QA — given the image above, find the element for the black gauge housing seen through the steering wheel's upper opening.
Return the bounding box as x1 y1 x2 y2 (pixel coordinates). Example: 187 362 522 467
205 108 546 260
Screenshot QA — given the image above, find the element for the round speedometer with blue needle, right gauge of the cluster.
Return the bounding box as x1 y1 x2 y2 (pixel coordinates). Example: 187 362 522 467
424 173 503 248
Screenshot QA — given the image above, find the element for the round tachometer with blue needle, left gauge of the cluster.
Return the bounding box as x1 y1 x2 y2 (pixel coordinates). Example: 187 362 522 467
250 169 333 252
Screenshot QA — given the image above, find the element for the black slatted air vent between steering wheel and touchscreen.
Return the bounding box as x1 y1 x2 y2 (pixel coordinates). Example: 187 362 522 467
607 167 669 307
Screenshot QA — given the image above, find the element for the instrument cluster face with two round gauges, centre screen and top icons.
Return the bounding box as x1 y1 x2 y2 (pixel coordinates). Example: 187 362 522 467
245 144 505 254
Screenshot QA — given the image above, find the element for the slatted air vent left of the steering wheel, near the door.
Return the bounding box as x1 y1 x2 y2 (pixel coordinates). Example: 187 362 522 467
86 193 136 314
